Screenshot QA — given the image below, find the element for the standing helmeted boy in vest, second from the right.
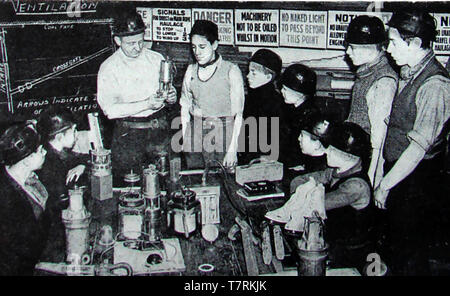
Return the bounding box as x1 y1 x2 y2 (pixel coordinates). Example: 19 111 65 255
345 15 398 186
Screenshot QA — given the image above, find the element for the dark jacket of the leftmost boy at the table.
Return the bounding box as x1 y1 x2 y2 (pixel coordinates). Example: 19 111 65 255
0 167 50 275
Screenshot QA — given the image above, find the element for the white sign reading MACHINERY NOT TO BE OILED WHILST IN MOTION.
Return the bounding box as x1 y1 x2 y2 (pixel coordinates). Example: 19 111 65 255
234 9 279 46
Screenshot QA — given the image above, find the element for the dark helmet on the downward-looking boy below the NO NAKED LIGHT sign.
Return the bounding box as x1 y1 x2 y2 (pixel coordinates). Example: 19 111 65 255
281 64 317 97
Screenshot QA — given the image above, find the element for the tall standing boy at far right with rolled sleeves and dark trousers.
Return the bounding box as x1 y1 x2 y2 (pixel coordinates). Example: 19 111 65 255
375 10 450 275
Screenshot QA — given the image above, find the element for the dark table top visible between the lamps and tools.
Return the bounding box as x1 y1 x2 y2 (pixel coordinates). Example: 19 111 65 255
39 175 284 276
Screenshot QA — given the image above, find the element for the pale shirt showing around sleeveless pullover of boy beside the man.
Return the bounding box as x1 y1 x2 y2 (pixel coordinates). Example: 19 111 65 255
180 57 245 117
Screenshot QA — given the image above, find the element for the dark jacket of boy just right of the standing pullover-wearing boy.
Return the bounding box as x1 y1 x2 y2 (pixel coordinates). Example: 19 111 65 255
239 83 284 164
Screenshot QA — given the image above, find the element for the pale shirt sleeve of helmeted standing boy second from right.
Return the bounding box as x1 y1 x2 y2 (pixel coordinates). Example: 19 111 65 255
366 77 397 148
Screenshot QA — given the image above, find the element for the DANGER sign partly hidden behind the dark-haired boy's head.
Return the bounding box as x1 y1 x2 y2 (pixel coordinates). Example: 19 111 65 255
192 8 234 45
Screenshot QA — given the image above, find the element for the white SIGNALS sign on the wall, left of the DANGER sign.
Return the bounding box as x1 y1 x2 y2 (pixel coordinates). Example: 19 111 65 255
153 8 192 43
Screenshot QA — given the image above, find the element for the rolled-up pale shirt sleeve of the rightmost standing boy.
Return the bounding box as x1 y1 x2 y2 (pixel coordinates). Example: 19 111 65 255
408 76 450 151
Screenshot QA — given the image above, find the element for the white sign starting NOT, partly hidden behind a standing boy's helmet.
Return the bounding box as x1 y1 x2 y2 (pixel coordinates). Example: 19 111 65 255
327 10 392 49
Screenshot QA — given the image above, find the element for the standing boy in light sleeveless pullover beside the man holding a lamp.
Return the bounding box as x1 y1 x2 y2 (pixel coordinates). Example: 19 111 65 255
180 20 245 168
